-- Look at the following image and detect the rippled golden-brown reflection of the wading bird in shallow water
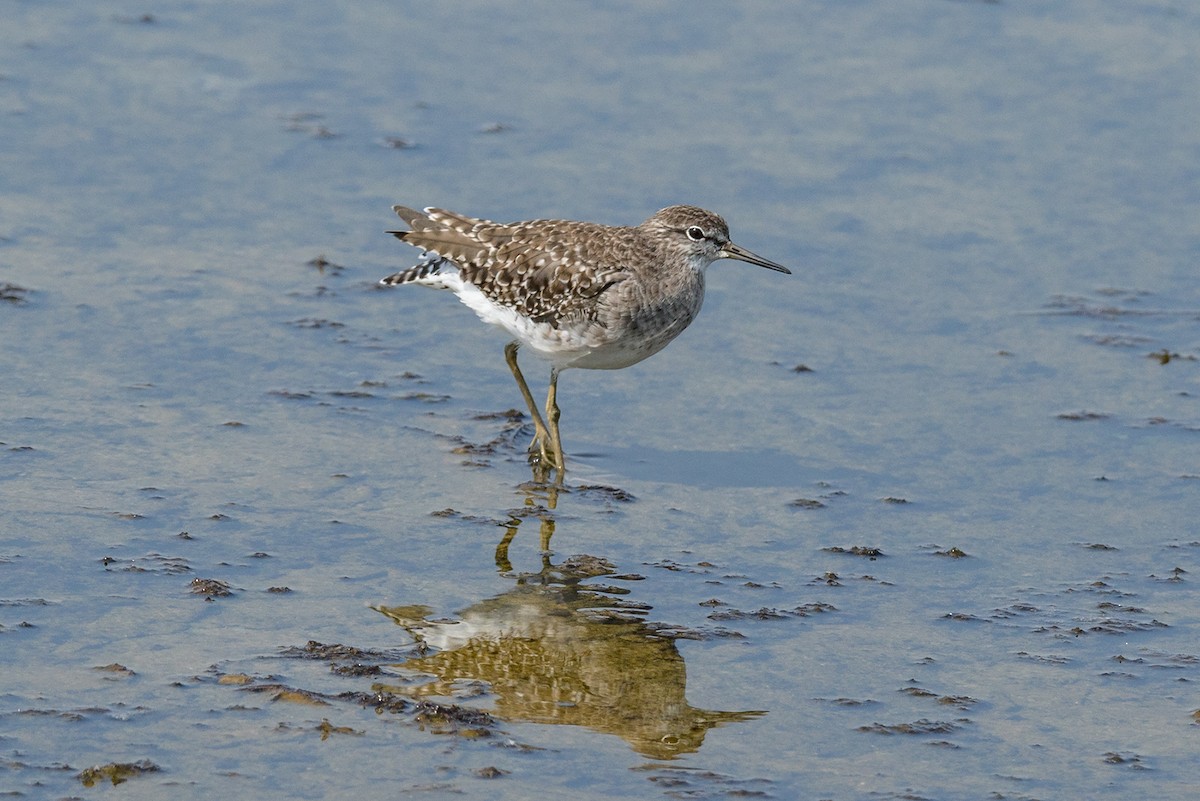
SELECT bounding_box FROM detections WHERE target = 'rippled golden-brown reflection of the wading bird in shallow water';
[377,470,762,759]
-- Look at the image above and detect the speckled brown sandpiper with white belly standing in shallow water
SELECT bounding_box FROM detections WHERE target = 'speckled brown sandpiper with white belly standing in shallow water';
[379,205,792,474]
